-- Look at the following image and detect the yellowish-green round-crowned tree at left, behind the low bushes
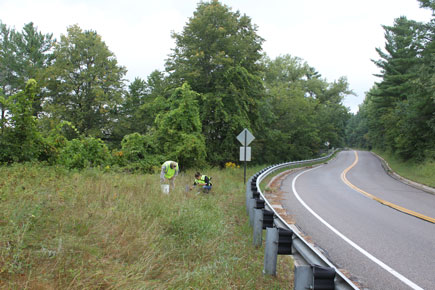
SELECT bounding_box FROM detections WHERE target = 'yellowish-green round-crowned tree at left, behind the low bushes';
[47,25,126,137]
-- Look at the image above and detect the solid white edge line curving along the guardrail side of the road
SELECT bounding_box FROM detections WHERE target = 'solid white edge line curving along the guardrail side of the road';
[292,165,424,290]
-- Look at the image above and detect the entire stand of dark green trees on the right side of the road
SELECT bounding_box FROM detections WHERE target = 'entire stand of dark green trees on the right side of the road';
[346,0,435,161]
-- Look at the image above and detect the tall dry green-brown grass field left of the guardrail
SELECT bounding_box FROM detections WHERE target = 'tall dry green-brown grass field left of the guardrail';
[0,164,293,289]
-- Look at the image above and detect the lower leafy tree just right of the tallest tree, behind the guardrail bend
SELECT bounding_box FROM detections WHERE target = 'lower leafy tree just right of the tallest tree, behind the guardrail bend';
[258,55,352,162]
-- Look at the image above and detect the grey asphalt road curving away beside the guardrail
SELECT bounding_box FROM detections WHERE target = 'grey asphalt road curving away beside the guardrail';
[281,151,435,290]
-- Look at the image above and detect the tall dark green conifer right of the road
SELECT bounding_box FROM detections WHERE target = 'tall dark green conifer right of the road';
[369,17,434,159]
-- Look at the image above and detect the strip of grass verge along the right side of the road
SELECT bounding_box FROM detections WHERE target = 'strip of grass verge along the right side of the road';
[373,150,435,187]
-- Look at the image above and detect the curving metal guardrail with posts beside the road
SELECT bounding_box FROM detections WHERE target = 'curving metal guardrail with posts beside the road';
[246,150,359,290]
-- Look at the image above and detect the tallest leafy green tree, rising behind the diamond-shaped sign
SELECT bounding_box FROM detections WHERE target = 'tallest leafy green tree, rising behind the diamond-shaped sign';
[166,1,264,165]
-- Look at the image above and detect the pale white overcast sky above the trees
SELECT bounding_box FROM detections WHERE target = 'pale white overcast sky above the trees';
[0,0,431,112]
